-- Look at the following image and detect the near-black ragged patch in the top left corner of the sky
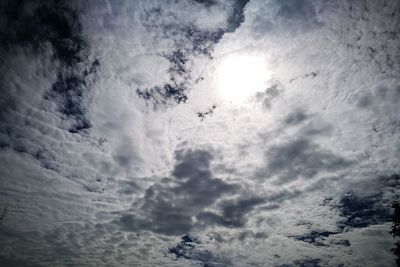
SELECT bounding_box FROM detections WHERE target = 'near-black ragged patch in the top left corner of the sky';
[0,0,100,133]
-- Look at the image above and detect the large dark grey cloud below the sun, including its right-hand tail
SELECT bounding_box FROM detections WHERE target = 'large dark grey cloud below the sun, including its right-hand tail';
[120,150,288,235]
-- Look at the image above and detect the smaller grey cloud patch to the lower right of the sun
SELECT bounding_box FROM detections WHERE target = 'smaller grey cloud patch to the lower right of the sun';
[256,111,346,184]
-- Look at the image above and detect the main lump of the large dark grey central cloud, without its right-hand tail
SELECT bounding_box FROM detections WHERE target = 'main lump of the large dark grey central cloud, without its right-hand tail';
[119,150,238,235]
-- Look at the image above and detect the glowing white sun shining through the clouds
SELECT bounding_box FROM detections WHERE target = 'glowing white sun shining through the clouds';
[215,54,269,104]
